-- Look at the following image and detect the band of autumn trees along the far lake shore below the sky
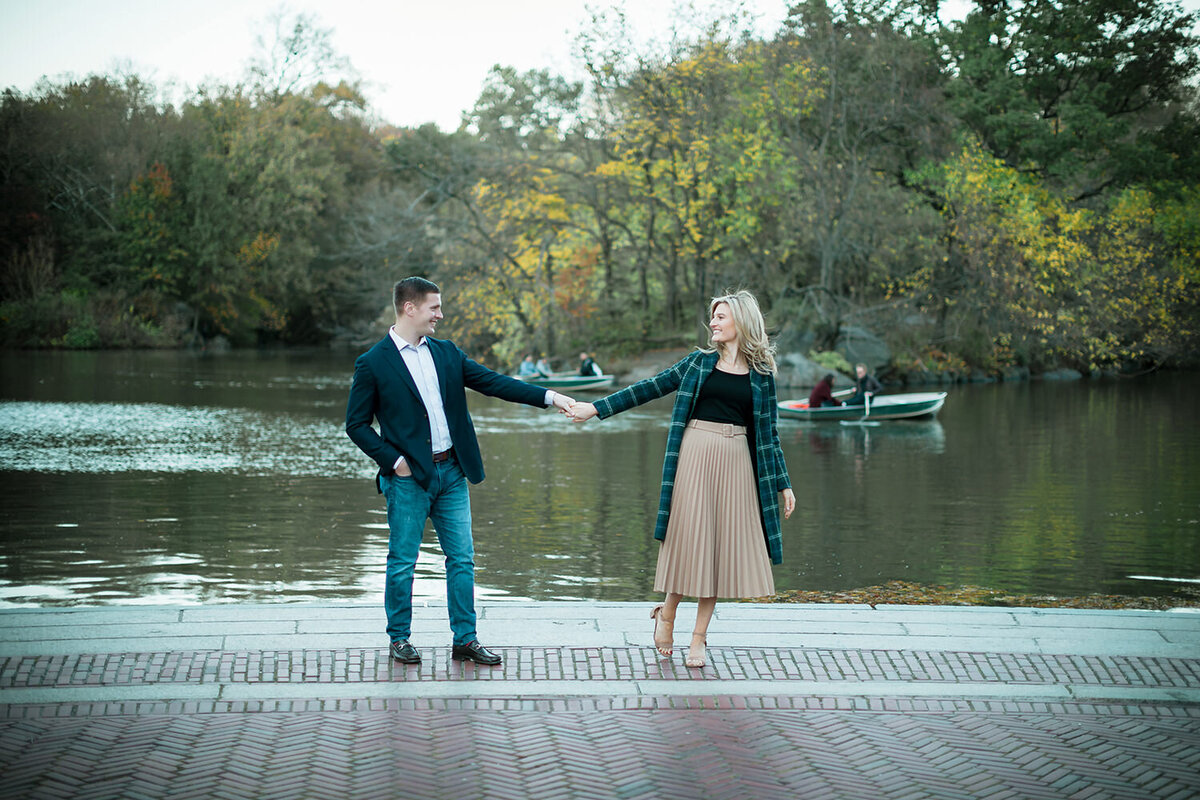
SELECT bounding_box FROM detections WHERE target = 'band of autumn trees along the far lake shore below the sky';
[0,0,1200,374]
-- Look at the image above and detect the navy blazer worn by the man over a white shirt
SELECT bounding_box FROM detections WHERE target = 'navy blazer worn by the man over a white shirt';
[346,336,546,492]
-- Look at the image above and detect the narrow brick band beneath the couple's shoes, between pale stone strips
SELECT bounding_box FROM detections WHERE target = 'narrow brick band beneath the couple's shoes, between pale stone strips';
[0,646,1200,688]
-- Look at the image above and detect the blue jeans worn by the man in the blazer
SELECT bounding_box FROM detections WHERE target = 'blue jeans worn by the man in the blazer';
[383,458,475,644]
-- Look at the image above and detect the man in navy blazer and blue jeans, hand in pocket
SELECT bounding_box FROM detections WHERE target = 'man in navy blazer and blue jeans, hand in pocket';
[346,277,575,666]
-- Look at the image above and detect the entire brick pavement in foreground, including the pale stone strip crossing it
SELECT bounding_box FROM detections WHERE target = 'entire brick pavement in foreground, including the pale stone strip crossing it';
[0,612,1200,800]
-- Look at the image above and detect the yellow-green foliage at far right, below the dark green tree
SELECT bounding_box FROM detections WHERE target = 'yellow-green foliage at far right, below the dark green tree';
[941,133,1200,366]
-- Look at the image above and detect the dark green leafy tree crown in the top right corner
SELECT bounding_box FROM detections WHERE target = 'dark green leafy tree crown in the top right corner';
[943,0,1200,200]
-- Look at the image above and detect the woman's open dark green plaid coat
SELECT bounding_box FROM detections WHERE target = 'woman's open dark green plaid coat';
[593,350,792,564]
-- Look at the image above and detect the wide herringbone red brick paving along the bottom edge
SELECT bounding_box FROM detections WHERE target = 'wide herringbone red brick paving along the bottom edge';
[0,709,1200,800]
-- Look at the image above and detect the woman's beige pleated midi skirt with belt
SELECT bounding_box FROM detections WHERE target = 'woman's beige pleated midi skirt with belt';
[654,420,775,597]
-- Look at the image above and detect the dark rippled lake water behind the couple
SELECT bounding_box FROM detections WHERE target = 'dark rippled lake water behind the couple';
[0,350,1200,607]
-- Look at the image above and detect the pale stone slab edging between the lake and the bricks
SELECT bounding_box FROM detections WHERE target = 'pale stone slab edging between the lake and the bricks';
[0,601,1200,657]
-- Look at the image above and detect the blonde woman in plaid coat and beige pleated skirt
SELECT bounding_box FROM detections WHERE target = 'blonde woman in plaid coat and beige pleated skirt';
[569,291,796,667]
